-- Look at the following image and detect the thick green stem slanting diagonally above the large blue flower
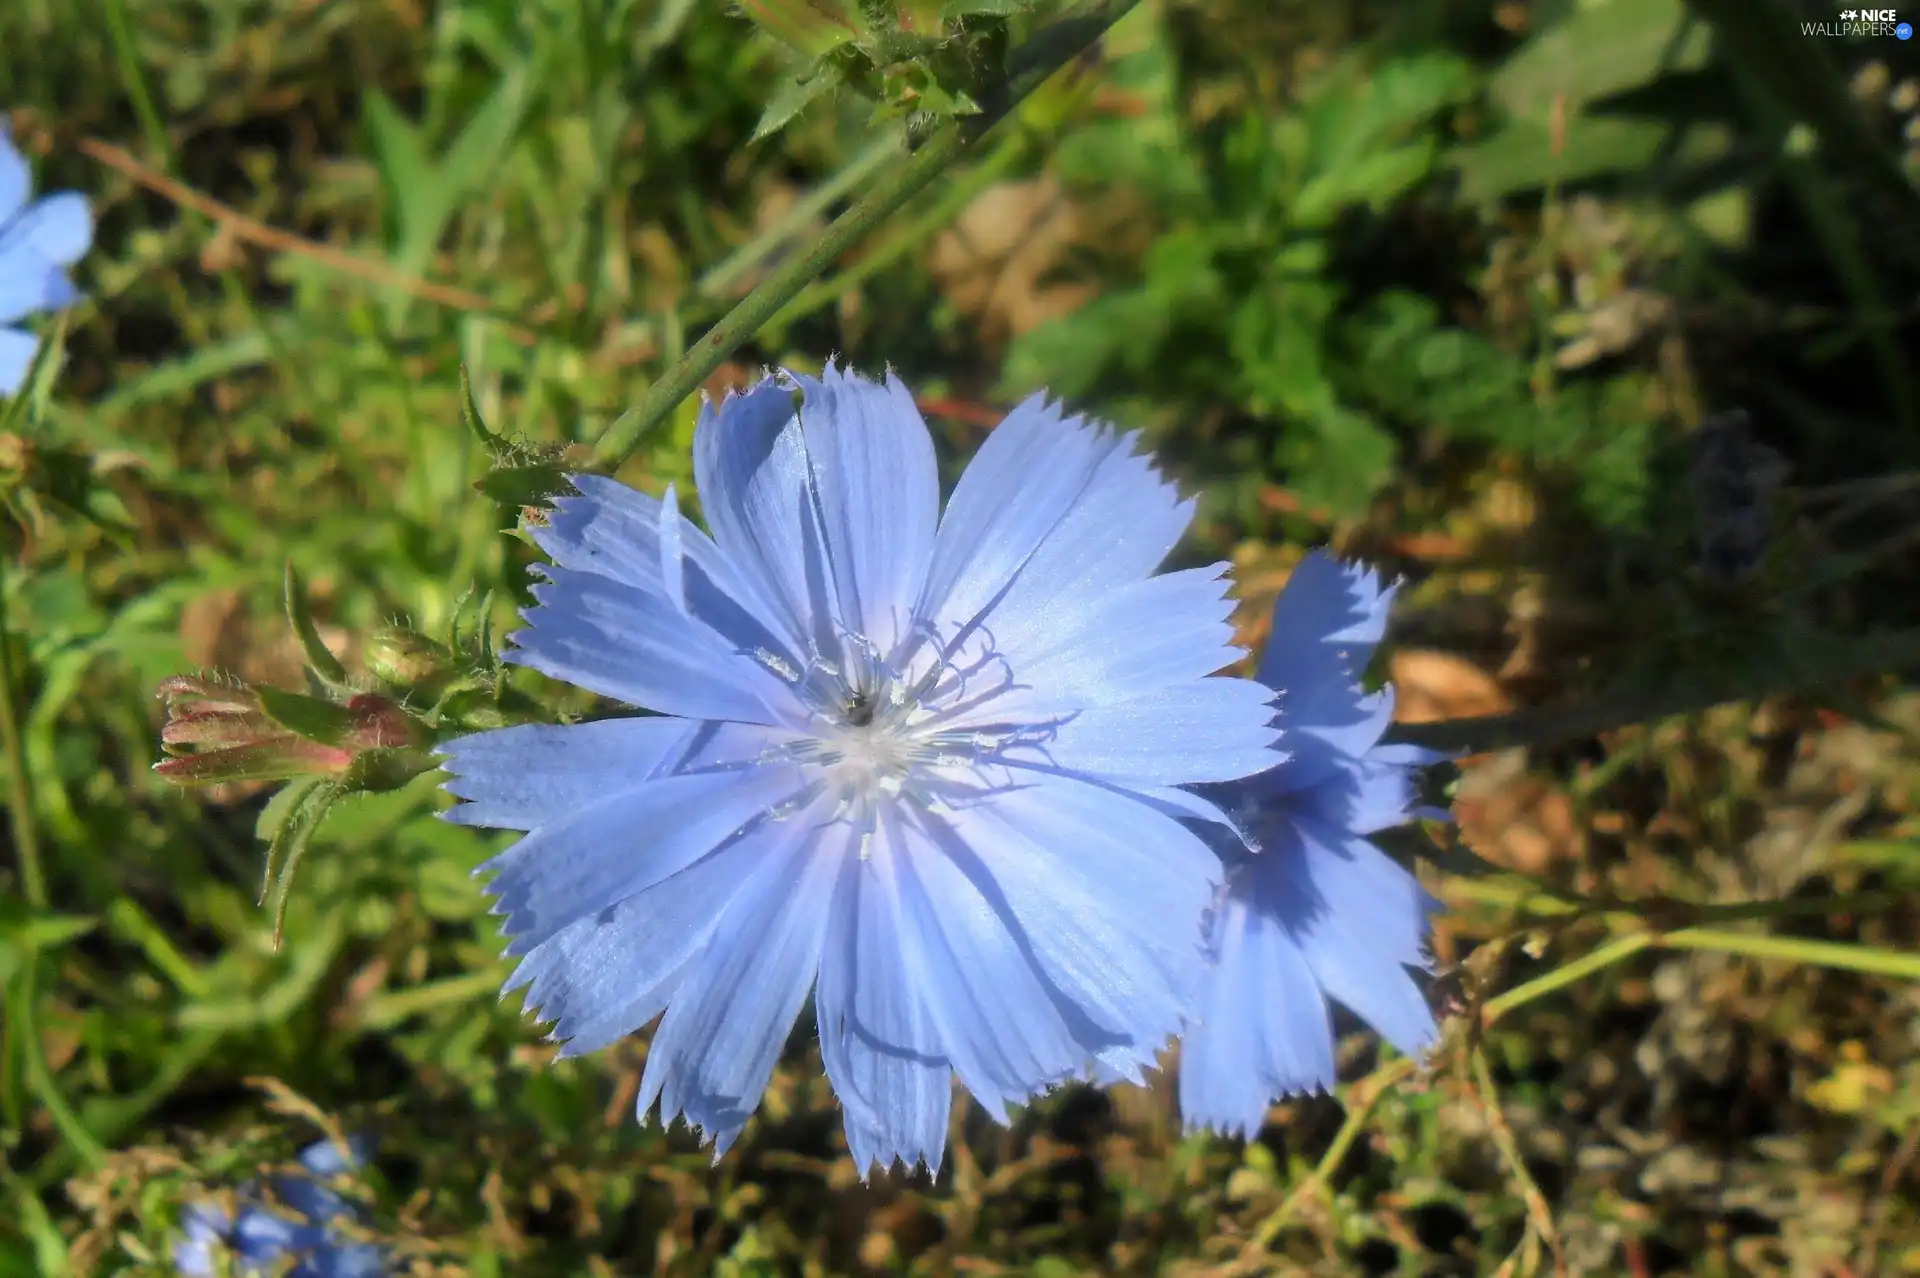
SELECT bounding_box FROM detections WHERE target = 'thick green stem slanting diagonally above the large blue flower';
[591,0,1139,470]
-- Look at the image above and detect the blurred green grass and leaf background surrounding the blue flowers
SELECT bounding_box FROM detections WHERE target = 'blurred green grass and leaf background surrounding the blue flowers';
[0,0,1920,1278]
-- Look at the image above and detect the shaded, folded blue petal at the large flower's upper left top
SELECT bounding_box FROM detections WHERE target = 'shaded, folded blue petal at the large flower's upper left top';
[693,380,839,652]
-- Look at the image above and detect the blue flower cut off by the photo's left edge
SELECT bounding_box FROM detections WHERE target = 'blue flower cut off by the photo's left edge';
[0,122,94,395]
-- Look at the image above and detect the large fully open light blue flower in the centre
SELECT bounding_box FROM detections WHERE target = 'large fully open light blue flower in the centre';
[444,368,1275,1174]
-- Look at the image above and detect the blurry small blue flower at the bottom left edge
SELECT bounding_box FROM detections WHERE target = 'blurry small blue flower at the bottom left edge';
[173,1140,388,1278]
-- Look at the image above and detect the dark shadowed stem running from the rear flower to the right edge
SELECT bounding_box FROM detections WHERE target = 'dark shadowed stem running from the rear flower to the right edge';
[1386,629,1920,754]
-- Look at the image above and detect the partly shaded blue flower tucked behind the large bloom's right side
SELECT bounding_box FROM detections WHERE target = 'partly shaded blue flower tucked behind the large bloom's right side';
[1179,553,1446,1136]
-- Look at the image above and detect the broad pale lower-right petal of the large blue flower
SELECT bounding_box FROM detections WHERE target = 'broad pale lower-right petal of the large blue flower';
[937,779,1219,1075]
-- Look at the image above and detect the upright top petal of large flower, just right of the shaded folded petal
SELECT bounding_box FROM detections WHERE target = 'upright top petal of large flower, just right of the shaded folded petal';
[795,367,941,654]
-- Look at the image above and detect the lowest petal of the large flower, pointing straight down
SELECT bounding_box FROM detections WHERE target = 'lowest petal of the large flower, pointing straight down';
[814,821,952,1178]
